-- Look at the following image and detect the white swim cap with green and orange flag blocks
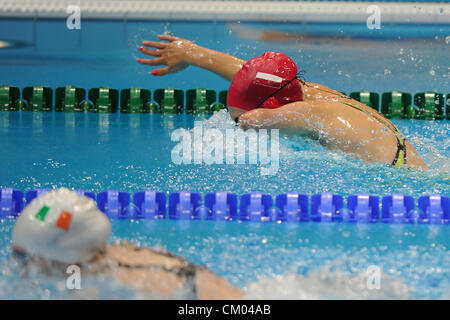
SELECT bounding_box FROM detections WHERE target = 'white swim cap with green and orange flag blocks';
[12,188,111,263]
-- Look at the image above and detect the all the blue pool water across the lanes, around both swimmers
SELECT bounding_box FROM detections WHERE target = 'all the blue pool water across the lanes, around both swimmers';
[0,19,450,299]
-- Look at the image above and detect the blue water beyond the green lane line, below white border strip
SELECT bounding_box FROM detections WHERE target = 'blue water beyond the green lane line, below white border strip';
[0,19,450,93]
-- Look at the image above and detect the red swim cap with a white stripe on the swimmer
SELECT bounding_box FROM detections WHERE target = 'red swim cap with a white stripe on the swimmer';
[227,52,303,110]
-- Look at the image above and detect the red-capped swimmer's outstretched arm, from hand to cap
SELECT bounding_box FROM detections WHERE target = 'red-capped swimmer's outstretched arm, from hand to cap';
[138,35,246,81]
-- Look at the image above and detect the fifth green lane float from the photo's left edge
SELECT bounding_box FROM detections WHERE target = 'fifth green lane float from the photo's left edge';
[120,88,155,113]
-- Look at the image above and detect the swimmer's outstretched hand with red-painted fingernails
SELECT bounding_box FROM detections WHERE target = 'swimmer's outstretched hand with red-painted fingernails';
[138,35,192,76]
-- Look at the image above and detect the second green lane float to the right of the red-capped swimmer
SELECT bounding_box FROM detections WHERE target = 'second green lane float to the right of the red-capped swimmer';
[381,91,415,118]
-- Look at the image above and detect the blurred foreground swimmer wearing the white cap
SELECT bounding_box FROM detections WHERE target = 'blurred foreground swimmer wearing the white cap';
[12,188,242,300]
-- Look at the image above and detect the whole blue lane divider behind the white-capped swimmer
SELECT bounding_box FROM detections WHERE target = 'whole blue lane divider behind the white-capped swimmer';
[0,188,450,224]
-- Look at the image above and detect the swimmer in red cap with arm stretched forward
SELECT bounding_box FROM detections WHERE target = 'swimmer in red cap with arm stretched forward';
[138,35,428,169]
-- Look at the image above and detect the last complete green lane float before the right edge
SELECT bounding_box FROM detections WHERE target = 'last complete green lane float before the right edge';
[414,91,448,120]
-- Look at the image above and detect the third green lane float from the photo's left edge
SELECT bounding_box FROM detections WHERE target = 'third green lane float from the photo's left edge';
[55,86,86,112]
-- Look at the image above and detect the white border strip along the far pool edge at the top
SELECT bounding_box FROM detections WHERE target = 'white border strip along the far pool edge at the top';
[0,0,450,24]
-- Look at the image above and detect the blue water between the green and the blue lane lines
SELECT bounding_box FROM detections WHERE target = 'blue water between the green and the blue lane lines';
[0,112,450,197]
